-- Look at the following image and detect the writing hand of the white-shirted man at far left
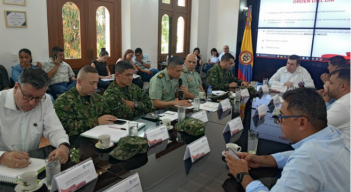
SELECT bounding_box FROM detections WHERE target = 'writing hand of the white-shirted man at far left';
[0,152,30,168]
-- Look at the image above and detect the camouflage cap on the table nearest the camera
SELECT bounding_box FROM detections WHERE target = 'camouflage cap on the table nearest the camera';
[110,136,148,160]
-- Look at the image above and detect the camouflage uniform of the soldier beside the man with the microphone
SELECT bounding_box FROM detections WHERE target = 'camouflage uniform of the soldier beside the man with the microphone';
[103,81,152,120]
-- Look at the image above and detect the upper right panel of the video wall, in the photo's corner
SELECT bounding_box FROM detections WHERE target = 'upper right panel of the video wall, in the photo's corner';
[316,0,351,28]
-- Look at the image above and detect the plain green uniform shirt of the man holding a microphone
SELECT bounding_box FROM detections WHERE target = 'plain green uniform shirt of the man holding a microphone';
[149,68,178,101]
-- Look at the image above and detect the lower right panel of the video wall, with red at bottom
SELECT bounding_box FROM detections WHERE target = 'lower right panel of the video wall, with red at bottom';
[312,29,351,61]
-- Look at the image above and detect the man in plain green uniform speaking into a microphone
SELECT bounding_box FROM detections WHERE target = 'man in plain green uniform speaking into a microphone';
[149,56,191,108]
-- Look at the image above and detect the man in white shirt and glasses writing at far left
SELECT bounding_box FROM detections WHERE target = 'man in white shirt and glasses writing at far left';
[0,68,69,168]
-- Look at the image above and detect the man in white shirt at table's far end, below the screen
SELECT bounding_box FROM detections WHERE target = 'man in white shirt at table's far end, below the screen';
[269,55,314,88]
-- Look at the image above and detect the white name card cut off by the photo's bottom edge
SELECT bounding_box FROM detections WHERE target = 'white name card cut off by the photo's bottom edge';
[104,173,143,192]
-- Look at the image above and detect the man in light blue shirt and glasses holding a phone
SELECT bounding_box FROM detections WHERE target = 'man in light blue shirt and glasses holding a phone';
[226,88,351,192]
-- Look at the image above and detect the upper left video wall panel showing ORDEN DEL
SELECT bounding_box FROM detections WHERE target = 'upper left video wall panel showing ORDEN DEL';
[258,0,318,28]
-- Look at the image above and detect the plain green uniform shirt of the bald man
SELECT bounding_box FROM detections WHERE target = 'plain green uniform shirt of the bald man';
[180,65,202,96]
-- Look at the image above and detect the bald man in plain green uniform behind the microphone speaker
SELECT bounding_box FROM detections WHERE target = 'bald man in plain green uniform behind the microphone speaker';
[180,54,205,99]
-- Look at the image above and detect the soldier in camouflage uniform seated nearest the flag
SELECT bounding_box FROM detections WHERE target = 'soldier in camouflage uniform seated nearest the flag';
[206,53,248,91]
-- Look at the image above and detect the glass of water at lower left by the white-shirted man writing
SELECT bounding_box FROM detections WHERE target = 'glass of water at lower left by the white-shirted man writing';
[45,156,61,190]
